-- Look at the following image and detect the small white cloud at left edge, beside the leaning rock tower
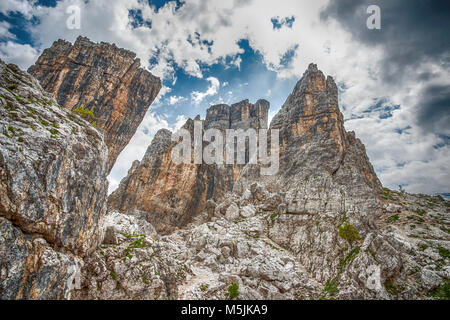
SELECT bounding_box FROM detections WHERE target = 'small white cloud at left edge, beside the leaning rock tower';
[0,41,38,70]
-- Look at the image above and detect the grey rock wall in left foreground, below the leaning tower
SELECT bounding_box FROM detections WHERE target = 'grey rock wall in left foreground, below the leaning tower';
[0,61,108,299]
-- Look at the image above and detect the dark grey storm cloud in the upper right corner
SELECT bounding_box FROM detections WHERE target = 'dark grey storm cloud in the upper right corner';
[321,0,450,133]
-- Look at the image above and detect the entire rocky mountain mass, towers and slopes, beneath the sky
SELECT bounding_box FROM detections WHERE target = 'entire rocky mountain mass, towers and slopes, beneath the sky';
[0,38,450,299]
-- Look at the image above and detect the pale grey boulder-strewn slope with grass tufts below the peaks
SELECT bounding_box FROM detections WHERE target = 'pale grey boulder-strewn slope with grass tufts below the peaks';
[73,190,450,299]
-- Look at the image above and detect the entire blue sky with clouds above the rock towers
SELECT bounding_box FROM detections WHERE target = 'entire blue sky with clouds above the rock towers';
[0,0,450,193]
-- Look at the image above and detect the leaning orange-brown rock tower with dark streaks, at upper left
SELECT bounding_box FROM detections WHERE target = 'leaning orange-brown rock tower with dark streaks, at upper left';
[28,37,161,171]
